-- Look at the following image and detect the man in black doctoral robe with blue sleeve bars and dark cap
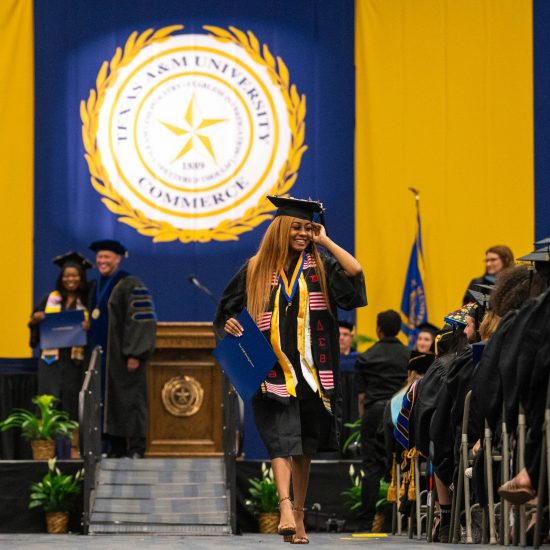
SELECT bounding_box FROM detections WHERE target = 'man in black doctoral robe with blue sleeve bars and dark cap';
[89,240,156,458]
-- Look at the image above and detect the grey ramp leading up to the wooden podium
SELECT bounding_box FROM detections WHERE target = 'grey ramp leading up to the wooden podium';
[89,458,231,535]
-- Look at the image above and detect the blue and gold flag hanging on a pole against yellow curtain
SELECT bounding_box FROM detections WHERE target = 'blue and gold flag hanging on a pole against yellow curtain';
[401,189,428,348]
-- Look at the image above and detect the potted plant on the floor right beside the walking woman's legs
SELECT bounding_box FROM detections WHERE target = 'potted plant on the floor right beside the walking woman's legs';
[245,462,279,533]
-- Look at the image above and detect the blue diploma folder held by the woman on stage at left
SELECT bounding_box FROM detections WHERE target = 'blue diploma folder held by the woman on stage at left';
[40,309,86,349]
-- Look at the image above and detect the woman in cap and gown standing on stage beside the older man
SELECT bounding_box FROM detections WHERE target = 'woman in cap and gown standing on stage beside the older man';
[29,252,92,458]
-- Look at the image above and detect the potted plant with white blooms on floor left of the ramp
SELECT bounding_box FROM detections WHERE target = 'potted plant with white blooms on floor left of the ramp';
[29,458,84,533]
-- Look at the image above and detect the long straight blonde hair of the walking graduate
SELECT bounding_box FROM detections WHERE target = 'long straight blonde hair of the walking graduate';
[246,216,330,320]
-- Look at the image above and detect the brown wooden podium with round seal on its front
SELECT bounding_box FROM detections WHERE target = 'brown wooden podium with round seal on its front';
[145,323,223,457]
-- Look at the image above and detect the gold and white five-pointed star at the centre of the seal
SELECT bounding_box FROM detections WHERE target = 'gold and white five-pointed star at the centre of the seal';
[160,93,227,164]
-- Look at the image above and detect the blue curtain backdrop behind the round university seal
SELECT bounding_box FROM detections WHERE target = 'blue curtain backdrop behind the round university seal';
[34,0,355,458]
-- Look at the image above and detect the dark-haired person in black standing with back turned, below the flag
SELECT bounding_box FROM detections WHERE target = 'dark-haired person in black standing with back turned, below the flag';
[355,310,410,531]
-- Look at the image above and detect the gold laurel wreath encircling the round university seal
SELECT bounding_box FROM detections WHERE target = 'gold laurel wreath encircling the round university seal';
[80,25,307,243]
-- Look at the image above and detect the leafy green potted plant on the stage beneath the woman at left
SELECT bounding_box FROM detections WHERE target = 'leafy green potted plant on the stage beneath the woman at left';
[0,395,78,460]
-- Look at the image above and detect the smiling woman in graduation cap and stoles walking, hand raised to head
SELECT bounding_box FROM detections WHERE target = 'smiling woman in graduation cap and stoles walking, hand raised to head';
[214,196,367,544]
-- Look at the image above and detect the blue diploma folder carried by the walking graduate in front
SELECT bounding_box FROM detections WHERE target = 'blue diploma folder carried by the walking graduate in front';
[212,309,277,400]
